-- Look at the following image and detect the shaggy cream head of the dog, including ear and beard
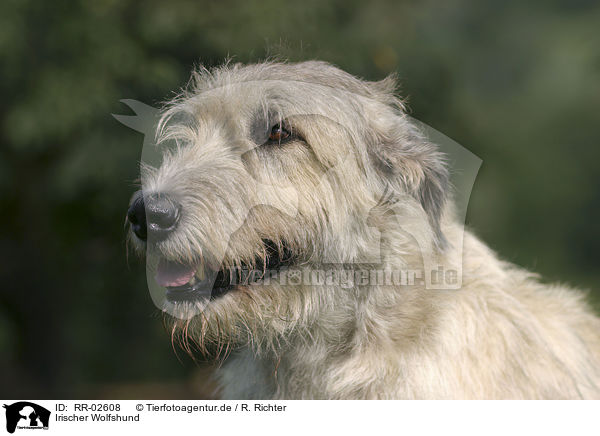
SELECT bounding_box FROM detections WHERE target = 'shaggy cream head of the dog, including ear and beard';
[128,62,447,354]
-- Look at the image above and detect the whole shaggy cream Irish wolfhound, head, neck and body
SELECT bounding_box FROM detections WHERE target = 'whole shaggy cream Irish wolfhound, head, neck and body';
[128,62,600,399]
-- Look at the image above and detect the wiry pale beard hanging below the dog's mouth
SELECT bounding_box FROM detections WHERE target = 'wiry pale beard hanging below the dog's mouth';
[165,272,352,361]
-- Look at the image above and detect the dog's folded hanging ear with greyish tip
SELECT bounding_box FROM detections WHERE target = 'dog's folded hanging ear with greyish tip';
[370,114,449,248]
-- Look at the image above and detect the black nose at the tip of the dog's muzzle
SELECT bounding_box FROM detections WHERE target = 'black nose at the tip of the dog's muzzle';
[127,193,180,241]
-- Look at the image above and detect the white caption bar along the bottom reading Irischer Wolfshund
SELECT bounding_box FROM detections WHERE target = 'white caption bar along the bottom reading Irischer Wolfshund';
[0,400,600,436]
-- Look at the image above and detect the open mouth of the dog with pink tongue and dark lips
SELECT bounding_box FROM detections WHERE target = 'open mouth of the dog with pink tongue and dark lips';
[155,240,295,303]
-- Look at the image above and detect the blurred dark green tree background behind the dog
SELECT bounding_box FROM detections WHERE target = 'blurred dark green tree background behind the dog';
[0,0,600,398]
